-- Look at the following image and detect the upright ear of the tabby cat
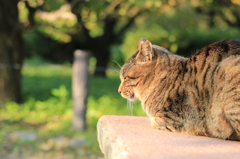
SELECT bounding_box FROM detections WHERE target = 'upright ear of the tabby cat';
[137,38,154,62]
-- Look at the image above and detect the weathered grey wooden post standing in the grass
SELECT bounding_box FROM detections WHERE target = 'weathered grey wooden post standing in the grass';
[72,50,89,131]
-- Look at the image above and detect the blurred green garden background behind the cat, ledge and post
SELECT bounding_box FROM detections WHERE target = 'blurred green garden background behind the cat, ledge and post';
[0,0,240,159]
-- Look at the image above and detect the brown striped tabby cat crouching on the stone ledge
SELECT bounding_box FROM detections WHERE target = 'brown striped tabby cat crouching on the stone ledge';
[118,38,240,140]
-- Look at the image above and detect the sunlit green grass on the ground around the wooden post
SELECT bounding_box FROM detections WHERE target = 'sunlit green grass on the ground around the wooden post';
[0,60,144,158]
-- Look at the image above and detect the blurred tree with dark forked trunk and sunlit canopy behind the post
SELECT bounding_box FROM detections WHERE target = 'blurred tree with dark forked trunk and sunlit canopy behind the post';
[18,0,159,76]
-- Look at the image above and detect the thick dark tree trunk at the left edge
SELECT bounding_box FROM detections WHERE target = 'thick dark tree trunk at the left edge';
[0,0,23,103]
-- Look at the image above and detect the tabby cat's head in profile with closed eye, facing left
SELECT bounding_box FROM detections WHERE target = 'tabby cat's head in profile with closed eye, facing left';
[118,38,158,100]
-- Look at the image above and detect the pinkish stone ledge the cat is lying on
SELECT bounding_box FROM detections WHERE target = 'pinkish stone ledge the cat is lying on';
[97,115,240,159]
